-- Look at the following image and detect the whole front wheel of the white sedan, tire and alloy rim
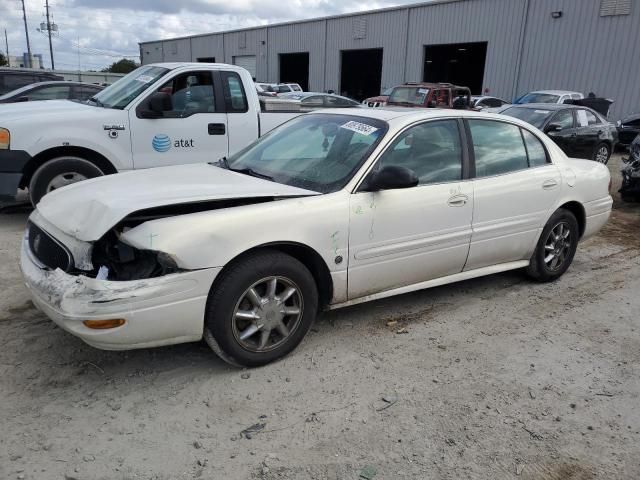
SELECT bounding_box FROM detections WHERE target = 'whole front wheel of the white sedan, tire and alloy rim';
[205,250,318,367]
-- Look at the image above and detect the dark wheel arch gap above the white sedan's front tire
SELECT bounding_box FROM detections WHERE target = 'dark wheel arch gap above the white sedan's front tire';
[212,241,333,310]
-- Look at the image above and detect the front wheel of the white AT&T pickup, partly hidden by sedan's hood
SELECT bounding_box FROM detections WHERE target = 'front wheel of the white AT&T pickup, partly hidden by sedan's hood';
[29,157,103,207]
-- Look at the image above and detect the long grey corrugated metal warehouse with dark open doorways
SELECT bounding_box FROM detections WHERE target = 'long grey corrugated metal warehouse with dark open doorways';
[140,0,640,120]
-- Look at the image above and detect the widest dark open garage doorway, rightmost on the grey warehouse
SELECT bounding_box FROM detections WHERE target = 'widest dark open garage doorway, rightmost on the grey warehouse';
[423,42,487,95]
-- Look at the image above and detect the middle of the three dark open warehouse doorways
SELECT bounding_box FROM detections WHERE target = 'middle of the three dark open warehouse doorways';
[340,48,382,101]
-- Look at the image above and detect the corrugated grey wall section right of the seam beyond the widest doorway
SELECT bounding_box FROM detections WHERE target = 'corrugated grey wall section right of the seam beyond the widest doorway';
[517,0,640,119]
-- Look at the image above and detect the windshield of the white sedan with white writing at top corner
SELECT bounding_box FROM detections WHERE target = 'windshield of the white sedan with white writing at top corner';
[227,113,388,193]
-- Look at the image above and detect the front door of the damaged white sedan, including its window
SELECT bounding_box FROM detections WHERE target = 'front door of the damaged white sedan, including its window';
[348,119,473,299]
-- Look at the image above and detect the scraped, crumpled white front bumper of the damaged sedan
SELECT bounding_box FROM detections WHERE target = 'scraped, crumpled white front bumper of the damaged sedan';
[20,235,221,350]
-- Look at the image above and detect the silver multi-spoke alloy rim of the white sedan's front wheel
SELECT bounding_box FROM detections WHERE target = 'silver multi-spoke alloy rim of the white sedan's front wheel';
[232,276,304,352]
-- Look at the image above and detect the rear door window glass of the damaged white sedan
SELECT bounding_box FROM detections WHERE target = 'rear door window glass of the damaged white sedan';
[469,120,529,177]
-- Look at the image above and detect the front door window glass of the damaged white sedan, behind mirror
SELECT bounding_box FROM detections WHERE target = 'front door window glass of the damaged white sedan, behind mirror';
[378,120,462,185]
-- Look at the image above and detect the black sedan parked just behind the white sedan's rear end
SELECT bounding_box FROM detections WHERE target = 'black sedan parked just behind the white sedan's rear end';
[501,103,618,164]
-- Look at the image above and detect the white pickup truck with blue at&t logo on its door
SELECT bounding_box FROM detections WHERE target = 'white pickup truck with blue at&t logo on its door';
[0,63,300,205]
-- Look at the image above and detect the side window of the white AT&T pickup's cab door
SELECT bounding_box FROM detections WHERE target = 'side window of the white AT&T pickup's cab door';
[157,71,215,118]
